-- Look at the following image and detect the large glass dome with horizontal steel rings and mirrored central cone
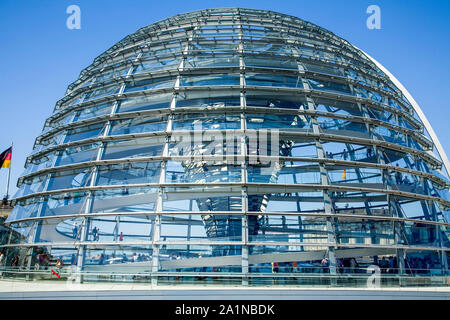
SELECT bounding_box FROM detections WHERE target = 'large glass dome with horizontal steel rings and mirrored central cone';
[3,8,450,283]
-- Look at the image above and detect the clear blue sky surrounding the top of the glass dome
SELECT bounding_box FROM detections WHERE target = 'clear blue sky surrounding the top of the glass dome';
[0,0,450,196]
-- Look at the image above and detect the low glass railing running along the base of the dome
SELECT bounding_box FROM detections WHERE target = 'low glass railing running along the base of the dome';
[0,266,450,289]
